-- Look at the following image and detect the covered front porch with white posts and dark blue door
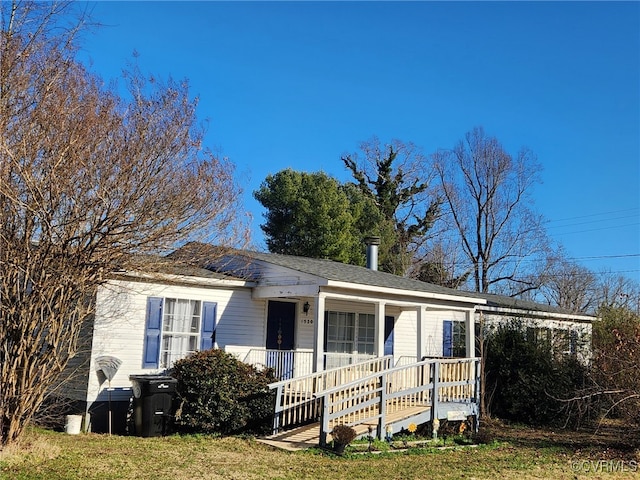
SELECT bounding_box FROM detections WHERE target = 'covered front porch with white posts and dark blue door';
[224,286,475,380]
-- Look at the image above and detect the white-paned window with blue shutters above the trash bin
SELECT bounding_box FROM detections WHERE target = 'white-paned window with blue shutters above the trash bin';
[143,297,216,368]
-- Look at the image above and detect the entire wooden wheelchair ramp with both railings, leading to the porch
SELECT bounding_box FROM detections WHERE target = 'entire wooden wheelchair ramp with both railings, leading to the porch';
[260,357,479,450]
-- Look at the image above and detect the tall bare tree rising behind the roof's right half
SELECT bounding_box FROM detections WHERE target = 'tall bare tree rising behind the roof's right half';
[433,128,547,295]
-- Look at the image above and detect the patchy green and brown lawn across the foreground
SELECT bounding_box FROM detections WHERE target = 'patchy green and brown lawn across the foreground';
[0,427,640,480]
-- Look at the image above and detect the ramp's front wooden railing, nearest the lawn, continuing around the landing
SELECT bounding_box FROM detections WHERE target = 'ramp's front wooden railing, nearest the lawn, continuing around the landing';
[315,358,479,445]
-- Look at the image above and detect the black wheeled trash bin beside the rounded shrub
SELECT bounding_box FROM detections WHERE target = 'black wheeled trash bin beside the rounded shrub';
[129,375,178,437]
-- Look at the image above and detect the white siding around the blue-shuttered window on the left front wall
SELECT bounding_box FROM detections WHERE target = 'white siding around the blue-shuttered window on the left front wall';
[87,281,265,403]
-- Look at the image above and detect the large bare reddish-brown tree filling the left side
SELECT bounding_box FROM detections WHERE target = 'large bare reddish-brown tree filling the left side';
[0,2,246,446]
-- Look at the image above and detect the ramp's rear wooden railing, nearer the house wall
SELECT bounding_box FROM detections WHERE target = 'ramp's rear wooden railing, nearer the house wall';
[269,356,393,433]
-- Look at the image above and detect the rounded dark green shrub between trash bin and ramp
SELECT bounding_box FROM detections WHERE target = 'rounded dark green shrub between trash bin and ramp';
[171,349,276,435]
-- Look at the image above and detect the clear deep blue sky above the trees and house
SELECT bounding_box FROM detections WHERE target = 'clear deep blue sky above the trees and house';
[77,1,640,281]
